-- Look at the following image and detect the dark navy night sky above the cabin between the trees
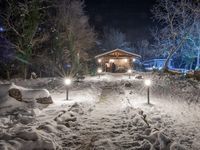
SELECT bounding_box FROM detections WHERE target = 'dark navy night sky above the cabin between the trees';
[85,0,155,42]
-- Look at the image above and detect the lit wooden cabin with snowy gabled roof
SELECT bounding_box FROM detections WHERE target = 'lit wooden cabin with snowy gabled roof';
[95,49,141,73]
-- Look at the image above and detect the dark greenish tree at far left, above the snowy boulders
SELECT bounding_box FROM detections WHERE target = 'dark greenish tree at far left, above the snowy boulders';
[1,0,40,79]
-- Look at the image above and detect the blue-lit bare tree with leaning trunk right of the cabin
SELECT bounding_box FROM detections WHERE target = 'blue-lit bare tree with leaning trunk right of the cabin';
[152,0,196,70]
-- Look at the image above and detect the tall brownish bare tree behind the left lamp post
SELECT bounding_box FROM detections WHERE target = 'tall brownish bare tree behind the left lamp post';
[50,0,96,75]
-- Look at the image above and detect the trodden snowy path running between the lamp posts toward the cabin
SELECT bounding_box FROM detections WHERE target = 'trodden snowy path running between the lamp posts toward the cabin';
[64,87,148,150]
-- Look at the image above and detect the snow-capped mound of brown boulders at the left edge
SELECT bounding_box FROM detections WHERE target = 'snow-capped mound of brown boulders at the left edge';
[0,84,53,114]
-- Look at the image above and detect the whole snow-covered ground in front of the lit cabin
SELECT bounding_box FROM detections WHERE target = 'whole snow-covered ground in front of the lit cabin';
[0,73,200,150]
